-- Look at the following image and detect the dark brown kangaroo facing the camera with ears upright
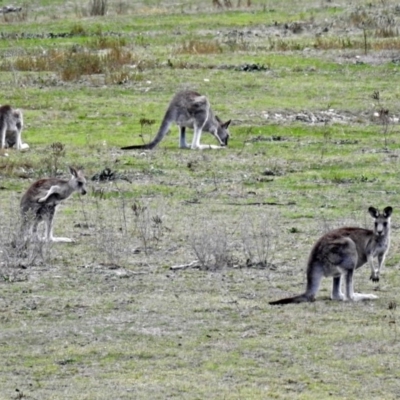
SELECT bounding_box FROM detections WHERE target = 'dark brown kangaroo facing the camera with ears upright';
[269,207,393,305]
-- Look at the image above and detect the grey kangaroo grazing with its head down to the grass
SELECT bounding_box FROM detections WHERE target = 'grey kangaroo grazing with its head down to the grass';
[122,91,231,150]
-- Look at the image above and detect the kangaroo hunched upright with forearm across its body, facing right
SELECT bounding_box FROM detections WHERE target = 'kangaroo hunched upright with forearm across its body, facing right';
[20,167,86,243]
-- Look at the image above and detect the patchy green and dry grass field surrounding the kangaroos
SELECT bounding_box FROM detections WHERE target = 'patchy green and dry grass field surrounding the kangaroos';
[0,0,400,400]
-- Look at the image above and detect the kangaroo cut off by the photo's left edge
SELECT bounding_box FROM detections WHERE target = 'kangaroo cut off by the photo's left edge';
[0,105,29,150]
